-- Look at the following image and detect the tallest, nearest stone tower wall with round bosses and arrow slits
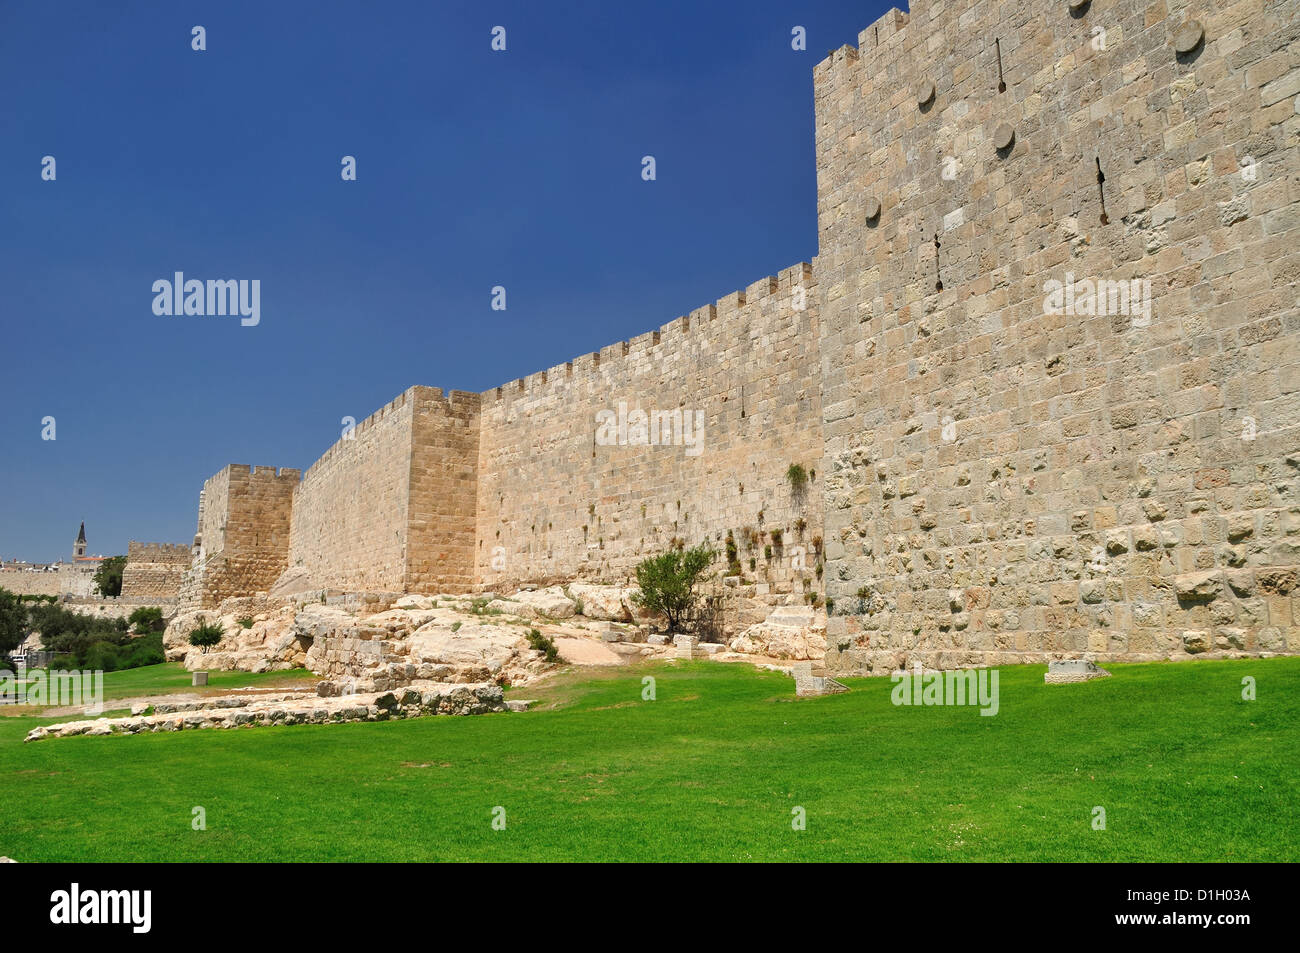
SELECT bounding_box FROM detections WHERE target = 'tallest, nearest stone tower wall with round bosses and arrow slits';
[814,0,1300,673]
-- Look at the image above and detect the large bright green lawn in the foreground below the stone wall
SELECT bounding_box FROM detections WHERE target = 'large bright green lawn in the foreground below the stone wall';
[0,658,1300,861]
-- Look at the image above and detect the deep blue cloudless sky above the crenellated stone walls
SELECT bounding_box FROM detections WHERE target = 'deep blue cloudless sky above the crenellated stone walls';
[0,0,888,560]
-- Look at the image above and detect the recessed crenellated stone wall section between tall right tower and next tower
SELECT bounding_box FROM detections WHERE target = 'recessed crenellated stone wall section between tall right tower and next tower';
[476,264,822,590]
